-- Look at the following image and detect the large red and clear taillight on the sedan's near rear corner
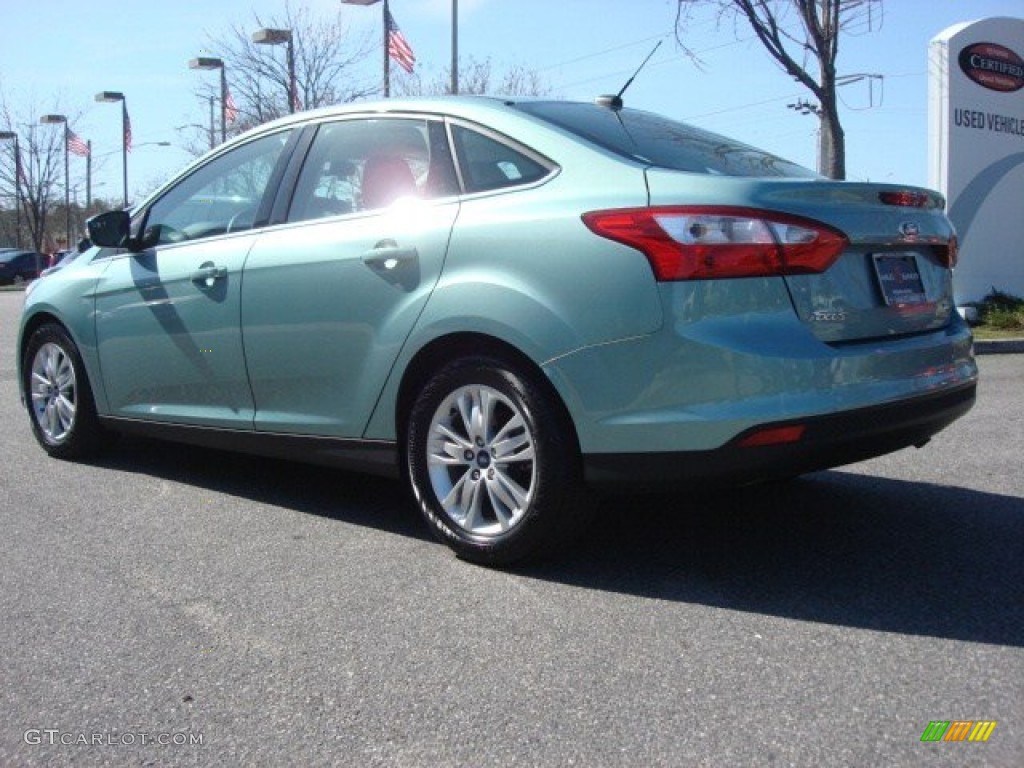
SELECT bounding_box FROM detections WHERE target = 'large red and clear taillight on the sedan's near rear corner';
[583,206,849,281]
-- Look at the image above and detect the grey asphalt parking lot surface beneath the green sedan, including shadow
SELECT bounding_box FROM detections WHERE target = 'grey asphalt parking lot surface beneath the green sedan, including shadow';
[0,293,1024,768]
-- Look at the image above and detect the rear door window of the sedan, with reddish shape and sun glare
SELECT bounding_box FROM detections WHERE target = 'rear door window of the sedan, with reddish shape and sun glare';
[288,118,458,221]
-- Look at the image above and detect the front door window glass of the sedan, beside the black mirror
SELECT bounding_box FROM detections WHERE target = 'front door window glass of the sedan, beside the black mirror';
[143,131,290,245]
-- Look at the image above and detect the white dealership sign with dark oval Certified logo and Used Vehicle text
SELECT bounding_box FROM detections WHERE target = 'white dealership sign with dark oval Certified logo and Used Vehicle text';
[928,18,1024,304]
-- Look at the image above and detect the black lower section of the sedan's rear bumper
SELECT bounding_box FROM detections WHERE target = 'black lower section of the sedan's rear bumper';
[584,381,977,492]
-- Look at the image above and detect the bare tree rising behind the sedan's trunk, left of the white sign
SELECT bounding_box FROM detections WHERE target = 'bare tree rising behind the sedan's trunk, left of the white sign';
[676,0,882,179]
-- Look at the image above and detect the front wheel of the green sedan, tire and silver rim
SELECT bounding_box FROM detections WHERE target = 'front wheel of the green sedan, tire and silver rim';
[22,323,110,459]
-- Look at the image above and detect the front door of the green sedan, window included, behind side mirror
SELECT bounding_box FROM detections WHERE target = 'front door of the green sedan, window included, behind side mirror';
[95,126,290,429]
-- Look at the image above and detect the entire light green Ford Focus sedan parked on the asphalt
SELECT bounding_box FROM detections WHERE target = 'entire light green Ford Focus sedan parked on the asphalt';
[18,97,977,564]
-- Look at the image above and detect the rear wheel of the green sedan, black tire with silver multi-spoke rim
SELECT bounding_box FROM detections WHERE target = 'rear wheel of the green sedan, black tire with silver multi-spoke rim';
[404,356,590,565]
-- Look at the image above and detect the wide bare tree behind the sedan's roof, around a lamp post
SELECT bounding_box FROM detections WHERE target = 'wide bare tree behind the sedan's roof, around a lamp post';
[183,3,378,152]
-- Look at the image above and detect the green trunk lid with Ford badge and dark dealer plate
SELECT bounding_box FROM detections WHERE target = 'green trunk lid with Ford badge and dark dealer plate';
[647,174,954,342]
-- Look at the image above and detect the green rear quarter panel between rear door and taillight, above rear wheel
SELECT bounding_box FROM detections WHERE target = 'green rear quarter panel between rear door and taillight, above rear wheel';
[366,147,663,439]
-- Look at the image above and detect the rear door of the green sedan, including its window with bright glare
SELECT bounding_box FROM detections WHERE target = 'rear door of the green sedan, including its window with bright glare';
[242,116,459,437]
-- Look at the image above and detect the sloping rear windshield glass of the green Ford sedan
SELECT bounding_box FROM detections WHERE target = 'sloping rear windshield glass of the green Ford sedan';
[515,101,817,178]
